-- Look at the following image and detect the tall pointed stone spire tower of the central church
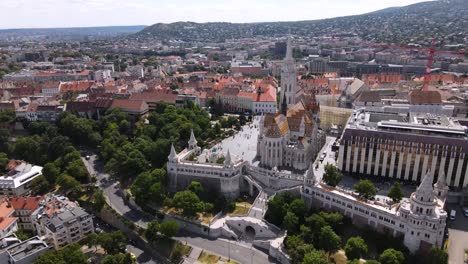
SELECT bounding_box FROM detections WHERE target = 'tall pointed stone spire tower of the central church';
[280,36,297,112]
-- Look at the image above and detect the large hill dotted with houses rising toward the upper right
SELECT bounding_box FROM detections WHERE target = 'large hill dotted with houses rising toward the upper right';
[131,0,468,44]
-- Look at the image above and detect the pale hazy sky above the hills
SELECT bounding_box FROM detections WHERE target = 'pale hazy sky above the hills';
[0,0,432,29]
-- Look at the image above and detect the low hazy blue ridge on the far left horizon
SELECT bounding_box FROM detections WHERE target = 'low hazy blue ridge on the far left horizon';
[0,26,146,39]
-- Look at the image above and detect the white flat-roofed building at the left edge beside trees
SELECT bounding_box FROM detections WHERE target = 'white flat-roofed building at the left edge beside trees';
[0,160,42,196]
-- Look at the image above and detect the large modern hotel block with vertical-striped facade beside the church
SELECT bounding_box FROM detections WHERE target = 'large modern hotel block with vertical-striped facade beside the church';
[337,110,468,188]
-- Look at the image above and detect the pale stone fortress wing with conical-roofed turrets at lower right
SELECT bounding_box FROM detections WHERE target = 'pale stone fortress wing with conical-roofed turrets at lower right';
[302,165,448,253]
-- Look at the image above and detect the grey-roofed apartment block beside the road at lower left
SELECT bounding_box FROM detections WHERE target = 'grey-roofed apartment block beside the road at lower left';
[32,194,94,249]
